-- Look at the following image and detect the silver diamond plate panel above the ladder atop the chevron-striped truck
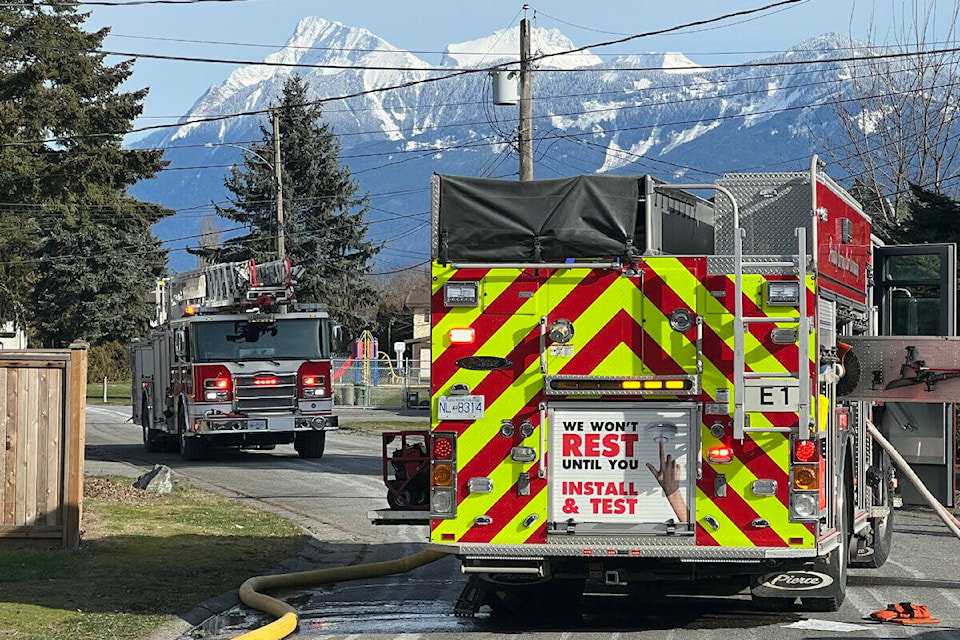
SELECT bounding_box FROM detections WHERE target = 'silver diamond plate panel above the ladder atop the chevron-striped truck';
[714,173,813,255]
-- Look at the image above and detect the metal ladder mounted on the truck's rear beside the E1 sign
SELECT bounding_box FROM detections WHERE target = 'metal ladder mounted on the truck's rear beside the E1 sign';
[733,225,811,440]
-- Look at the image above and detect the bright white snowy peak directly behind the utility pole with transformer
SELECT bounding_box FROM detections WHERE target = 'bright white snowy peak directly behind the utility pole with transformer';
[441,27,602,69]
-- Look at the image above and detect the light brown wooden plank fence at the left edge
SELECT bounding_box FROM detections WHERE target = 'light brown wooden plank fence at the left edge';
[0,344,87,549]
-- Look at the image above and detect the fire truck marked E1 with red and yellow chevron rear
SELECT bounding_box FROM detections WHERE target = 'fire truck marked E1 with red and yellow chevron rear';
[370,158,960,614]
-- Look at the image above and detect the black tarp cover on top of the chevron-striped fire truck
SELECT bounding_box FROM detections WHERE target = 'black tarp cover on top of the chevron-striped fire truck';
[434,175,645,262]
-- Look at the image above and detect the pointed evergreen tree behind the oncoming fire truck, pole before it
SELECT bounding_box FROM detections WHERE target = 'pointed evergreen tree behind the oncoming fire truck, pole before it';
[209,75,380,337]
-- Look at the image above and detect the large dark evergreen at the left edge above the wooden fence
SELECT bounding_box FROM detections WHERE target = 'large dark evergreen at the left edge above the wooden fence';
[0,1,170,347]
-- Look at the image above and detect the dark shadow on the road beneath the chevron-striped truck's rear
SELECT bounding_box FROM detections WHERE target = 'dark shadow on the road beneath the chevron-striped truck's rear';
[480,596,802,633]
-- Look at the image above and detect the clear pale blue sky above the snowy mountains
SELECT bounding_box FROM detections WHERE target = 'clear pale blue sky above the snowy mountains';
[86,0,955,132]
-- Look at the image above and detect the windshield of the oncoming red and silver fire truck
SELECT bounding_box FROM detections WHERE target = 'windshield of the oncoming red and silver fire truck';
[194,318,330,362]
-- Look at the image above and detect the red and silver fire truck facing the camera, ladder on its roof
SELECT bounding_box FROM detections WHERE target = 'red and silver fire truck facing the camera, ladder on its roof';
[131,260,337,460]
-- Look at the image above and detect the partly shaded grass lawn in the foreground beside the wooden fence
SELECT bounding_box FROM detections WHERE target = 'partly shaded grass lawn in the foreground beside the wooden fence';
[0,477,309,640]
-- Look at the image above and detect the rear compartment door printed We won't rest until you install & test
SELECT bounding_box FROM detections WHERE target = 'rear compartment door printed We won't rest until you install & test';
[548,403,698,535]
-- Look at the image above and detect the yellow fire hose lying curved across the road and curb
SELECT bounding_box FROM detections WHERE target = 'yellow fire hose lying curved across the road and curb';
[234,551,449,640]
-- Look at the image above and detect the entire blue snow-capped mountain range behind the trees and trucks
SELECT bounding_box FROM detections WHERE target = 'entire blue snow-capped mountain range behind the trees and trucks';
[134,18,867,270]
